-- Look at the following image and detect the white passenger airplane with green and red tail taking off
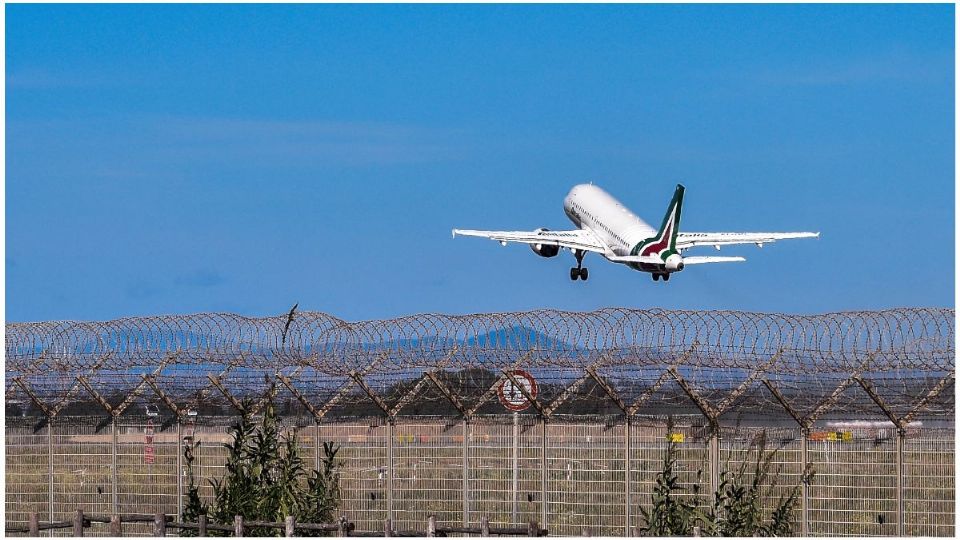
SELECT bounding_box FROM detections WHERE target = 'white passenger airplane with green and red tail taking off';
[453,183,820,281]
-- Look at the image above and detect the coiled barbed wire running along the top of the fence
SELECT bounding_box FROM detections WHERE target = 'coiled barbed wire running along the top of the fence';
[6,308,955,422]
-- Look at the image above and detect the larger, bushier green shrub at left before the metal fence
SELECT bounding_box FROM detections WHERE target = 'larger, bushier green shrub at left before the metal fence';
[183,400,340,536]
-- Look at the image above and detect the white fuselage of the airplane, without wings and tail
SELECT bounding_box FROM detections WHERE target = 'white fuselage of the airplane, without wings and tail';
[563,184,657,255]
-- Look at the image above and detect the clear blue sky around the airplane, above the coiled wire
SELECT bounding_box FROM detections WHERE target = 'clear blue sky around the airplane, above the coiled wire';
[6,5,954,321]
